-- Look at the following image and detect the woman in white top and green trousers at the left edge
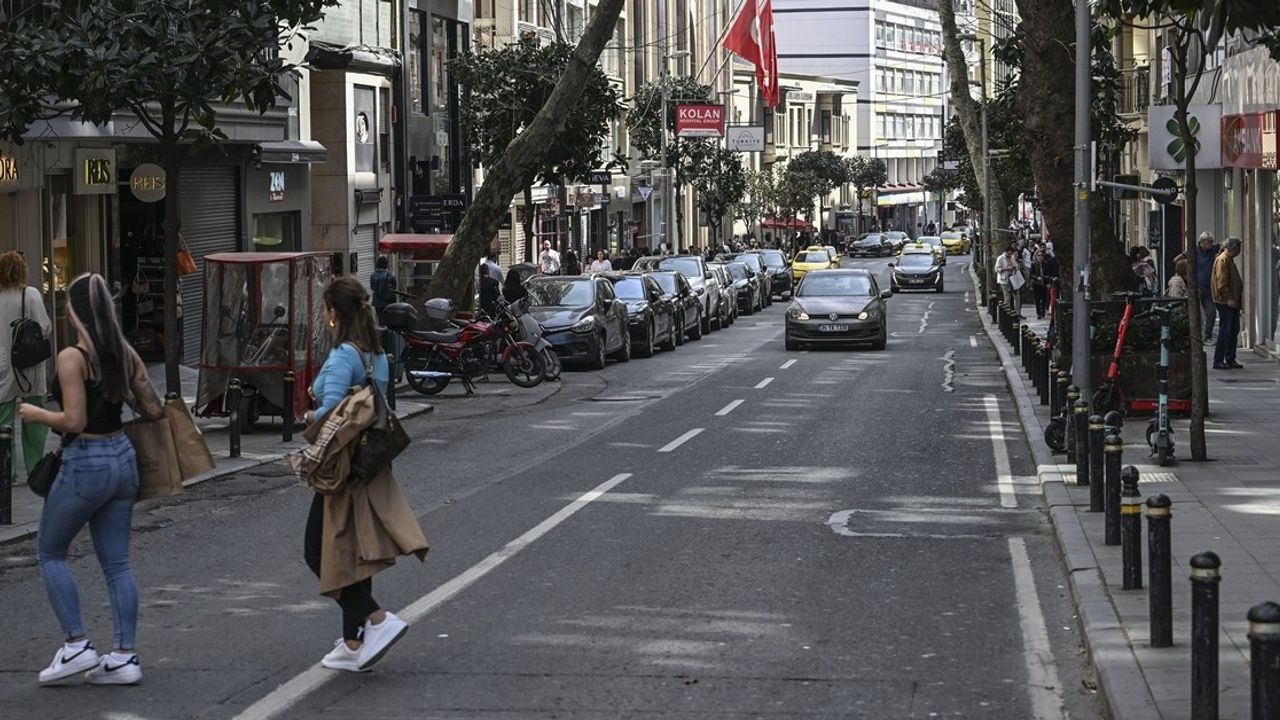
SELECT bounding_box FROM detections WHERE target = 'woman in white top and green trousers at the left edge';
[0,250,52,484]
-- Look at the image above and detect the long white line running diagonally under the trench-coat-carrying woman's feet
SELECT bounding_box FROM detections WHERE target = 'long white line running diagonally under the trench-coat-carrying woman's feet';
[236,473,631,720]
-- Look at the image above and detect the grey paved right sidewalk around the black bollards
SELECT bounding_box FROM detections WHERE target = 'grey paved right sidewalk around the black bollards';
[975,283,1280,720]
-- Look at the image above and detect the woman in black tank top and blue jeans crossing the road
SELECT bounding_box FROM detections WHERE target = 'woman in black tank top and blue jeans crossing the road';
[18,273,164,685]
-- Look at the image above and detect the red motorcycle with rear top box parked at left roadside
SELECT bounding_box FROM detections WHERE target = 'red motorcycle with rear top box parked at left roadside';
[383,299,547,395]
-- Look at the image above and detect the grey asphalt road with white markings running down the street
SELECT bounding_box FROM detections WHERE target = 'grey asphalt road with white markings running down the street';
[0,256,1100,720]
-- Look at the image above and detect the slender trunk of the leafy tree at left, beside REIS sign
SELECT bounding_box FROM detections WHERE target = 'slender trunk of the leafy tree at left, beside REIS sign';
[160,124,183,397]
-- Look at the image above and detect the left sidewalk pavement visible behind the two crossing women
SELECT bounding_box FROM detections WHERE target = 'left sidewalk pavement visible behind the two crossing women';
[0,365,450,544]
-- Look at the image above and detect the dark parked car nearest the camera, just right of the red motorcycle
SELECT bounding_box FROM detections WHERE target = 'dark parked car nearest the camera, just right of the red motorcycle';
[525,275,631,370]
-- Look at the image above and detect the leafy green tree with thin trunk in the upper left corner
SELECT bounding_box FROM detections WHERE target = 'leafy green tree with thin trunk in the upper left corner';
[0,0,337,391]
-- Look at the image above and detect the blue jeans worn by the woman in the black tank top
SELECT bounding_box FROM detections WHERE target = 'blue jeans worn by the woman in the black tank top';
[36,433,138,650]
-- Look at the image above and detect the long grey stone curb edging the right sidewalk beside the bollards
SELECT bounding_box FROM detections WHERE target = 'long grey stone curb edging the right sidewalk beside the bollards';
[970,270,1161,720]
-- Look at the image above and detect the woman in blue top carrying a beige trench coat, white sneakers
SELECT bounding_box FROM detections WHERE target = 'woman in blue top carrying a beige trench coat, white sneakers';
[296,277,426,673]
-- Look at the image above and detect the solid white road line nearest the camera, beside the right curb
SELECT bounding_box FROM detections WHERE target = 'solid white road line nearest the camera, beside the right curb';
[1009,538,1068,720]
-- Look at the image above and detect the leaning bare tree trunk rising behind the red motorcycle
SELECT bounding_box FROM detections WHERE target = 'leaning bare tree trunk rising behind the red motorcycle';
[431,0,625,306]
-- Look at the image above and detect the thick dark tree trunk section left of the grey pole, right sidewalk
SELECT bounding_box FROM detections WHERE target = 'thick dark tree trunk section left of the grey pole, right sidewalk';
[1016,0,1075,285]
